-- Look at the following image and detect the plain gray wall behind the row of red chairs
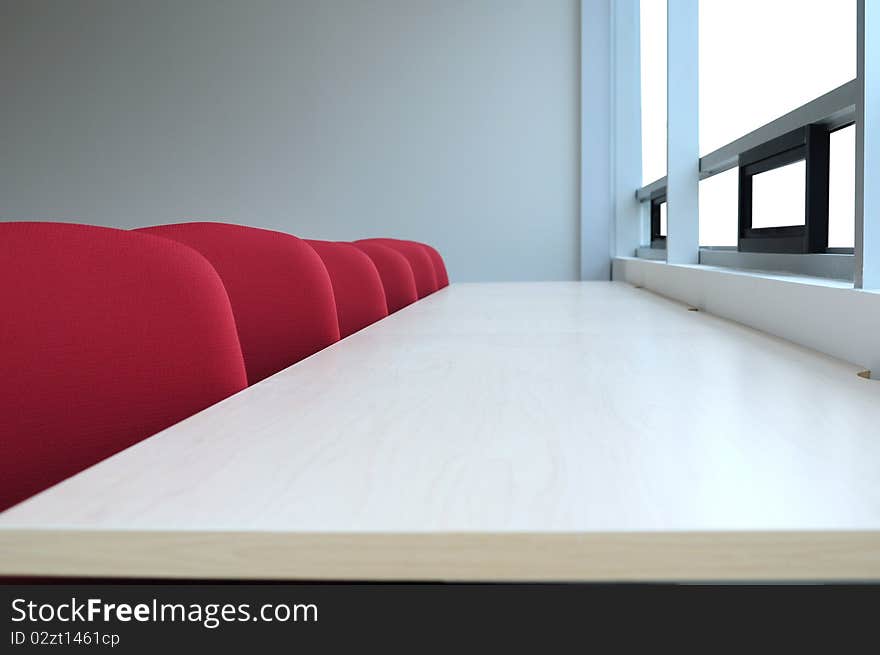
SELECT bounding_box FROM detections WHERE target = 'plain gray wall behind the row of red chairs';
[0,0,579,281]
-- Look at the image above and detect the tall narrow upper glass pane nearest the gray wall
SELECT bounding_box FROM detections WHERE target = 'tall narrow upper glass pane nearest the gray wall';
[639,0,666,184]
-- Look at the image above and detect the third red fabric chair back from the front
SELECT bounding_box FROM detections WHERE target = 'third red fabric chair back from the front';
[306,240,388,337]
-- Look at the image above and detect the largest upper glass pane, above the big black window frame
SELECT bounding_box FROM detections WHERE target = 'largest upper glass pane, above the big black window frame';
[696,0,856,154]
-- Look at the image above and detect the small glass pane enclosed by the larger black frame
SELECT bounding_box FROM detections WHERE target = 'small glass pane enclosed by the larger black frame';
[752,160,807,227]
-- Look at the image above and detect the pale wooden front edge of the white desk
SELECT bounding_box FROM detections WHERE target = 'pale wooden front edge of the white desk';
[0,528,880,582]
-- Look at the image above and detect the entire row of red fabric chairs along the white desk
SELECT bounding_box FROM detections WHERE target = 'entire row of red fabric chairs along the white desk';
[0,222,449,510]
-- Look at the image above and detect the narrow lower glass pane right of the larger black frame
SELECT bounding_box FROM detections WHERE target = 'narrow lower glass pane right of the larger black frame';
[828,125,856,248]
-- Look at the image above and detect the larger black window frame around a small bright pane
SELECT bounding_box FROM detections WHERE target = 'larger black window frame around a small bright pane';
[739,125,830,253]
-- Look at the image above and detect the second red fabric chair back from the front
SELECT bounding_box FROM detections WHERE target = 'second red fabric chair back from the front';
[140,223,339,384]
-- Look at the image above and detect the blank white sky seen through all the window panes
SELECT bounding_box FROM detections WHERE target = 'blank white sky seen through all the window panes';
[641,0,856,247]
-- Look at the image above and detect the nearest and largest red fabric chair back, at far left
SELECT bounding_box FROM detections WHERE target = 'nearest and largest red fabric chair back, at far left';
[0,223,247,509]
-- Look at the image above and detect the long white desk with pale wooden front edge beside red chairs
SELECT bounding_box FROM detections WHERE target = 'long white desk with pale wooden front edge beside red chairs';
[0,282,880,580]
